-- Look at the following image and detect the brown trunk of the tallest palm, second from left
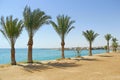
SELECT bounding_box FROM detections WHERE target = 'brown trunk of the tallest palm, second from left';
[28,36,33,63]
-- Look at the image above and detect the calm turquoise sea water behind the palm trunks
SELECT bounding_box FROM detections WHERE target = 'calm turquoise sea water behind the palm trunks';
[0,49,105,64]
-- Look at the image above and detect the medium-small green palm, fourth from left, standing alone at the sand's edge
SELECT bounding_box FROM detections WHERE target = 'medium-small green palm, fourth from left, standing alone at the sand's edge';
[83,30,99,56]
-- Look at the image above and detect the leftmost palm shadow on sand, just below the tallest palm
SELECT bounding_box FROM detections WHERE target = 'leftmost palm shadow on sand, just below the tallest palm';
[17,62,52,73]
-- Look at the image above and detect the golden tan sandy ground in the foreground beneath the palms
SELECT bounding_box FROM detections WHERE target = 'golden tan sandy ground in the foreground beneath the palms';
[0,53,120,80]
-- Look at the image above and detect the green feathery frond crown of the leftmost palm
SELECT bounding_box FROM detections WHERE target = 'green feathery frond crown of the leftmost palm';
[0,16,23,43]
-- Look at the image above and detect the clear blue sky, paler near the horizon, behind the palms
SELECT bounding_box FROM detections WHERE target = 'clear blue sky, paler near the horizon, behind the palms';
[0,0,120,48]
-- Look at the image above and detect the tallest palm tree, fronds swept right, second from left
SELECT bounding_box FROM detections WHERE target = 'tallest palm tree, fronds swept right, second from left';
[23,6,51,63]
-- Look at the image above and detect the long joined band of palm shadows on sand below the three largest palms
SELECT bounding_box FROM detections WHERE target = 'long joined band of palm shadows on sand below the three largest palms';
[17,61,80,73]
